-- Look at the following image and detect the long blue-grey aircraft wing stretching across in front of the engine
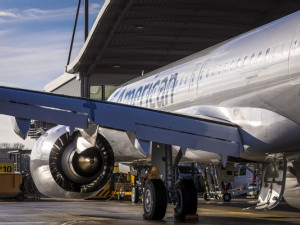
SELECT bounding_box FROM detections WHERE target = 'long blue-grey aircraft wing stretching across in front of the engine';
[0,87,243,163]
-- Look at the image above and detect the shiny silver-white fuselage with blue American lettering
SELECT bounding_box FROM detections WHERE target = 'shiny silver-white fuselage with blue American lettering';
[102,12,300,161]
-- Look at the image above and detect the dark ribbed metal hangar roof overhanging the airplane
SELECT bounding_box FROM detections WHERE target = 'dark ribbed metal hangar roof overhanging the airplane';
[67,0,300,81]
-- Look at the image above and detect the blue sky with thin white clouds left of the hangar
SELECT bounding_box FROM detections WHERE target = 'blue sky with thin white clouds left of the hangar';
[0,0,104,147]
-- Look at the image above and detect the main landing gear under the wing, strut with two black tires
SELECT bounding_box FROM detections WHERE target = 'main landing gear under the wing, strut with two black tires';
[143,143,197,220]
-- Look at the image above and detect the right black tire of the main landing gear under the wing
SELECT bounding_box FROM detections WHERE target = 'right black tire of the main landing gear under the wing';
[174,180,198,220]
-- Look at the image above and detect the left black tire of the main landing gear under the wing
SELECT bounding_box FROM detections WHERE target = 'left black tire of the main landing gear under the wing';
[143,179,167,220]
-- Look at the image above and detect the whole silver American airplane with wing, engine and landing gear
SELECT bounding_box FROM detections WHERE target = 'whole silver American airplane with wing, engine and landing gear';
[0,9,300,220]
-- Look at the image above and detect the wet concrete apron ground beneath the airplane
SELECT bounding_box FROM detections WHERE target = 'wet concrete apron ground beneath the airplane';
[0,198,300,225]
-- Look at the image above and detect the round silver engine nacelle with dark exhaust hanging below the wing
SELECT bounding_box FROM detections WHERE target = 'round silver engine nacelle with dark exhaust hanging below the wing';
[30,126,114,199]
